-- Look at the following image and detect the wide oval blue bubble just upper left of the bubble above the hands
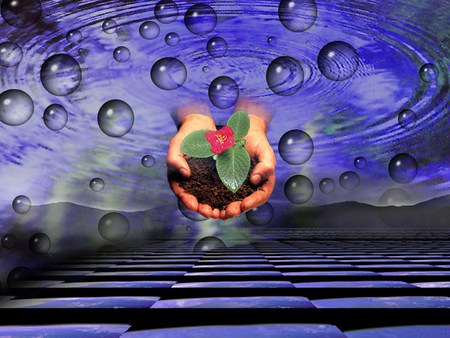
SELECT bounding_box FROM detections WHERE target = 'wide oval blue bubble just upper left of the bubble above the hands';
[150,57,187,90]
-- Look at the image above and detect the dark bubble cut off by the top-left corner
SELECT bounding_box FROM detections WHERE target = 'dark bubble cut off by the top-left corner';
[1,0,42,28]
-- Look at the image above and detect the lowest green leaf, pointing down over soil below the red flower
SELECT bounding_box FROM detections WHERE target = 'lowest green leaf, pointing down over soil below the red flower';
[216,146,250,193]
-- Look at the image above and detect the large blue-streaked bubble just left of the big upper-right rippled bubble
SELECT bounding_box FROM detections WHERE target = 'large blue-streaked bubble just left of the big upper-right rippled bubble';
[266,56,304,96]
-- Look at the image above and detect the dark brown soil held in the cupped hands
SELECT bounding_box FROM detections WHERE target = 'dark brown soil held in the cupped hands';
[177,157,260,210]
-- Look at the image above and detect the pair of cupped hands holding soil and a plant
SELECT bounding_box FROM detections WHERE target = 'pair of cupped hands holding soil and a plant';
[167,101,276,220]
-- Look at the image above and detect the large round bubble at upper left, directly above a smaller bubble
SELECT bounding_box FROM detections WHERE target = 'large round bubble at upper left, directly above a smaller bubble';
[41,54,81,96]
